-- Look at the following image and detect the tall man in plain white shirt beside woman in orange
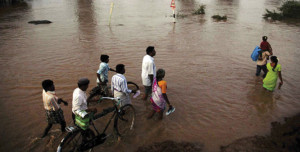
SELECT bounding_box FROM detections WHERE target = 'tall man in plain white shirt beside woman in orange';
[142,46,156,100]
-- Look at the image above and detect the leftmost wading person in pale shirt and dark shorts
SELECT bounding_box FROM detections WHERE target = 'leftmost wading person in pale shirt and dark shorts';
[42,80,68,138]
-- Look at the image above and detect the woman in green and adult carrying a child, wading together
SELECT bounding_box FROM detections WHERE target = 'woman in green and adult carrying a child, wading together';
[256,36,283,91]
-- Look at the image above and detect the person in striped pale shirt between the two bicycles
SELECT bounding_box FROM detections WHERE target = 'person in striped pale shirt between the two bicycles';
[111,64,136,107]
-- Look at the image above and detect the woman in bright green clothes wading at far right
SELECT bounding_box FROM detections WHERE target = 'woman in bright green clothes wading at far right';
[263,56,283,91]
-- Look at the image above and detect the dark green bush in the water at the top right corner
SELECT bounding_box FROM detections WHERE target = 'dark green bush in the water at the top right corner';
[263,0,300,20]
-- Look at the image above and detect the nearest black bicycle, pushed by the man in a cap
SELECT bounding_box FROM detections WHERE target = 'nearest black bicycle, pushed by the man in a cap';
[57,97,135,152]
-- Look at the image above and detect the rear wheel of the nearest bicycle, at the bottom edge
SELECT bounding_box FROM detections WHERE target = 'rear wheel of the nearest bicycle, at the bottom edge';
[57,129,95,152]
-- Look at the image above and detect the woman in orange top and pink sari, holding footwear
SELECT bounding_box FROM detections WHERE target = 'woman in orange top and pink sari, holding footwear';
[148,69,175,120]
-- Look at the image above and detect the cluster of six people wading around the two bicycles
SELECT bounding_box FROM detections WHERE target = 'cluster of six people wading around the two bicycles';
[42,46,175,138]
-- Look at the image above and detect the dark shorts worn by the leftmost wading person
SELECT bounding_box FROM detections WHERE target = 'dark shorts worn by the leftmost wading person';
[46,109,65,124]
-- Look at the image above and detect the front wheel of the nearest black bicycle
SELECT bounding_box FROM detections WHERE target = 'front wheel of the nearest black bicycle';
[114,104,135,136]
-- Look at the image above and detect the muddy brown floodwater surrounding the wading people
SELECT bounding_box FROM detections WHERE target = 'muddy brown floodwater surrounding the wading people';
[0,0,300,152]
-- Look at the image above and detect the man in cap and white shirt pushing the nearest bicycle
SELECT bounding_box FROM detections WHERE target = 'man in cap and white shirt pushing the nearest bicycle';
[72,78,97,123]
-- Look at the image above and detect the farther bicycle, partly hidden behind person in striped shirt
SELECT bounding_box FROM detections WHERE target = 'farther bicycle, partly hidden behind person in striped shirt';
[87,81,139,102]
